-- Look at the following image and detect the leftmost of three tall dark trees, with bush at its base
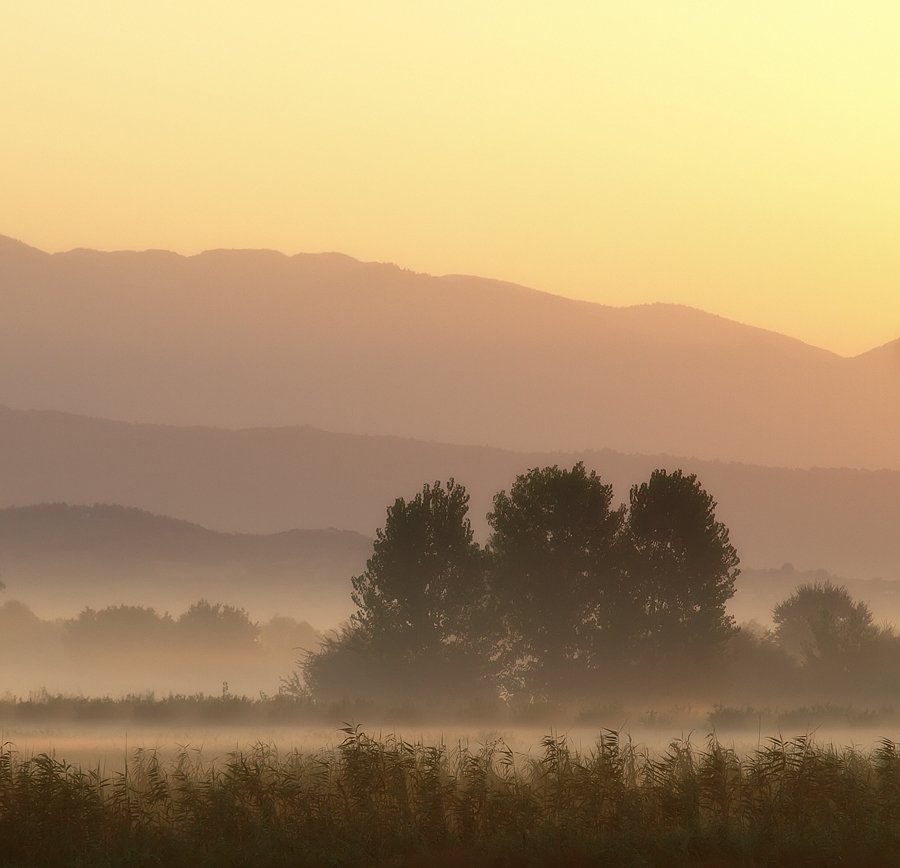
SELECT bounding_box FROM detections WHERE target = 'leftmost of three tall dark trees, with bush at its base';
[304,479,485,695]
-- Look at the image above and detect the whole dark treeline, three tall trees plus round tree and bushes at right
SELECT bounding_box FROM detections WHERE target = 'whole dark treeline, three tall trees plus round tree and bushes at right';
[298,463,900,708]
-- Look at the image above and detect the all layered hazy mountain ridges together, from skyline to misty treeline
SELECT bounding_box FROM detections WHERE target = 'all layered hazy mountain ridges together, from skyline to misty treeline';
[0,237,900,626]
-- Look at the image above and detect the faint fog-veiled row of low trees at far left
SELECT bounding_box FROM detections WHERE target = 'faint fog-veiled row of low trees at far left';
[0,600,321,696]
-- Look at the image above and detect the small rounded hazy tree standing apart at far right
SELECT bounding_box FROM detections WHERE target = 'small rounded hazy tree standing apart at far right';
[772,581,879,672]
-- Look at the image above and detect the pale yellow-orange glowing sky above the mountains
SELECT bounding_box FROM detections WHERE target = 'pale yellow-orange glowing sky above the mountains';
[0,0,900,355]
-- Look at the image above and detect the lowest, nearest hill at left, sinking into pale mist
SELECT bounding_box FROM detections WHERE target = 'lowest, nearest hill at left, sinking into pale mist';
[0,503,372,629]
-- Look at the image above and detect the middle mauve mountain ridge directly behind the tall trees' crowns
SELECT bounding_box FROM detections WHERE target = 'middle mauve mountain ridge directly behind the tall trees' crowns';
[0,409,900,584]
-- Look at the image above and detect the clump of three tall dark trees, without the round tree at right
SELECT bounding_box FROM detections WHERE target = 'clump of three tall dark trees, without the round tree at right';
[302,463,738,700]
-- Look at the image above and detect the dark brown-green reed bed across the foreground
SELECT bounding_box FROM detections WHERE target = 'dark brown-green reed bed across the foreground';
[0,726,900,866]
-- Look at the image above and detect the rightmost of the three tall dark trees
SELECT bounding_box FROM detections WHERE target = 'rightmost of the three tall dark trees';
[628,470,740,662]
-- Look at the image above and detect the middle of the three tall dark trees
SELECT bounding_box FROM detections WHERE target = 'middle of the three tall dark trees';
[488,462,626,696]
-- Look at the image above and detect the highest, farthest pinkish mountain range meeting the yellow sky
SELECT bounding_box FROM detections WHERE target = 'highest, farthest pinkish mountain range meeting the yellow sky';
[0,238,900,468]
